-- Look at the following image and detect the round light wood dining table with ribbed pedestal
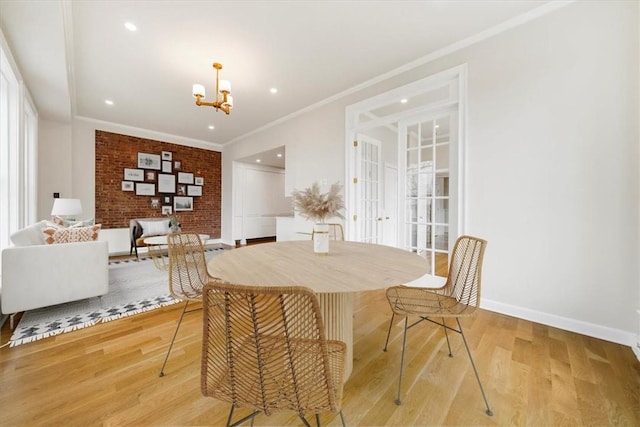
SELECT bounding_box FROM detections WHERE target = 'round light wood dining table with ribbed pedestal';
[208,240,427,379]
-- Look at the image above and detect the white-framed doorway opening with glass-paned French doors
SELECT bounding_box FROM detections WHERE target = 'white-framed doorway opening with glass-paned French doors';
[345,65,466,274]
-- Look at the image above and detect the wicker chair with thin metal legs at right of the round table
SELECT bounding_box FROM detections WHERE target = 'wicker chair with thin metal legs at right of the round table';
[384,236,493,415]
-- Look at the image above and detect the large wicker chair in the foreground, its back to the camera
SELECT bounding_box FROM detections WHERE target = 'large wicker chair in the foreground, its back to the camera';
[201,283,346,426]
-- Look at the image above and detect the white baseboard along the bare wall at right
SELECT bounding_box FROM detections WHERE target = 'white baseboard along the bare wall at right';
[480,299,640,360]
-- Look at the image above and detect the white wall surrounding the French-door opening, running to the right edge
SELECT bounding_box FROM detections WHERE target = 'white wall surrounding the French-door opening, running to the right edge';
[223,2,640,345]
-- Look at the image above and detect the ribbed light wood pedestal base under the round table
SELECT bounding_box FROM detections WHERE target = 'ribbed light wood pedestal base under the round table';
[318,292,353,381]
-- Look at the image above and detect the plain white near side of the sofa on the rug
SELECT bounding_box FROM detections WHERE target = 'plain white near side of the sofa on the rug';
[1,241,109,314]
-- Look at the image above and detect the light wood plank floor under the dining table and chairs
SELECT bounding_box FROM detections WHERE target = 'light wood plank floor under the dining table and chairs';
[0,284,640,426]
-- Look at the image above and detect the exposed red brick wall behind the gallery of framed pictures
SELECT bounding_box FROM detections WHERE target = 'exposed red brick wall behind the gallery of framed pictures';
[95,130,222,239]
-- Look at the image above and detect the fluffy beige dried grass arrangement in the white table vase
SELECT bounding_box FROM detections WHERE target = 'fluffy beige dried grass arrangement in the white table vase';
[291,182,344,223]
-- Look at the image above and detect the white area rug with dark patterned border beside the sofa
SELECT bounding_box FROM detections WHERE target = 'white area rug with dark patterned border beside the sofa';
[9,248,224,347]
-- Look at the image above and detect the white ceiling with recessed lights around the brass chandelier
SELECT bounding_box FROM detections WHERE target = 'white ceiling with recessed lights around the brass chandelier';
[0,0,548,149]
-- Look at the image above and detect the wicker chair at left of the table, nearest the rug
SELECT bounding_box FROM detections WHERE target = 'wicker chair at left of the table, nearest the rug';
[159,232,219,377]
